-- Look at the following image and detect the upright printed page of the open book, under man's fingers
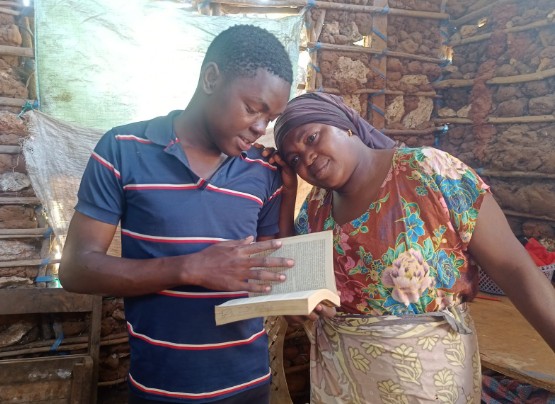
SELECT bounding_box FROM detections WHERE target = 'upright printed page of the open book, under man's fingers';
[250,230,337,296]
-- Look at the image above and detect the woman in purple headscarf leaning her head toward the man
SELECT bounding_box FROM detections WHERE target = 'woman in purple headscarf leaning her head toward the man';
[274,93,555,403]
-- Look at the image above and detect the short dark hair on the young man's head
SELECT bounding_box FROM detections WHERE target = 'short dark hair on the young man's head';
[202,25,293,84]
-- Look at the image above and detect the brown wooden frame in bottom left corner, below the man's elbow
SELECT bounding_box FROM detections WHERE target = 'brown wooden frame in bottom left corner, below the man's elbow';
[0,289,102,404]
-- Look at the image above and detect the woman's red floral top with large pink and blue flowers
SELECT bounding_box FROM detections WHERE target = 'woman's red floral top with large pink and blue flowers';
[295,148,488,316]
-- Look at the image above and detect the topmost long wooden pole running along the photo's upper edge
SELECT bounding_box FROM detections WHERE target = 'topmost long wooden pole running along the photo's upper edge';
[206,0,449,20]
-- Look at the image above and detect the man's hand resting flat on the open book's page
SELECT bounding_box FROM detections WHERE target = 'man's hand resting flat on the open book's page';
[185,236,295,293]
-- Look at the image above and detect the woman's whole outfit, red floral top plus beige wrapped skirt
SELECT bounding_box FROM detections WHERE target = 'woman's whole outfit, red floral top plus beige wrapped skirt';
[295,148,488,404]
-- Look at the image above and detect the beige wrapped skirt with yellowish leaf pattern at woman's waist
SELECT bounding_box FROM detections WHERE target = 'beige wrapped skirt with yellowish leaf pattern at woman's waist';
[307,304,482,404]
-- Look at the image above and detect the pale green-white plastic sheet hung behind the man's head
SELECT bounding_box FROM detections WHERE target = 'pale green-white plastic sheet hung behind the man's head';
[35,0,302,130]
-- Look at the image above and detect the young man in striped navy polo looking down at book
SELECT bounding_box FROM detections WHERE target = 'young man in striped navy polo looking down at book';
[60,25,293,404]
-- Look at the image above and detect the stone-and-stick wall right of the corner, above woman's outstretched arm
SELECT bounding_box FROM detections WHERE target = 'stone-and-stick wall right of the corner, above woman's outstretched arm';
[438,0,555,239]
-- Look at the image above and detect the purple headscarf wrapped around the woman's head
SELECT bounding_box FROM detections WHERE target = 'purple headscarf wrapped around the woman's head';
[274,92,395,150]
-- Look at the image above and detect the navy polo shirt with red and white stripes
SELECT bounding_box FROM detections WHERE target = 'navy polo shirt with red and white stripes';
[75,111,281,403]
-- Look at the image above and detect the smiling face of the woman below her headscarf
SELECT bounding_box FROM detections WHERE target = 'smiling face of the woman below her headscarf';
[280,123,355,189]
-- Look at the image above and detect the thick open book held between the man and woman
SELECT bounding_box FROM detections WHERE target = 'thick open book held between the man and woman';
[215,231,339,325]
